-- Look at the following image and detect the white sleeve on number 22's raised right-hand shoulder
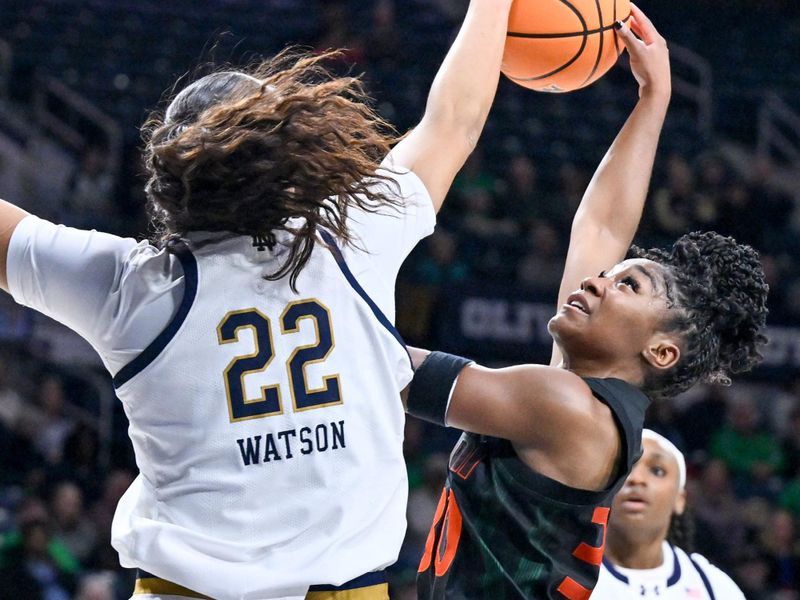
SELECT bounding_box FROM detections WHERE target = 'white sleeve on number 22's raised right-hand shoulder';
[348,169,436,287]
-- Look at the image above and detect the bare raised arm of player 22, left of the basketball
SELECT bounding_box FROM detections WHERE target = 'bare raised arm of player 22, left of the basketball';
[387,0,511,211]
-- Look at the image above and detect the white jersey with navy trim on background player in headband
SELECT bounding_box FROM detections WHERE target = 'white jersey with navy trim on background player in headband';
[590,542,744,600]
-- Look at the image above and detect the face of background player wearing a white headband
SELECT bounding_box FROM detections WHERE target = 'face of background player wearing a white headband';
[609,439,685,532]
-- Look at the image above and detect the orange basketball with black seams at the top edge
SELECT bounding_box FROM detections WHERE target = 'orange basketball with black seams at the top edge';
[502,0,630,92]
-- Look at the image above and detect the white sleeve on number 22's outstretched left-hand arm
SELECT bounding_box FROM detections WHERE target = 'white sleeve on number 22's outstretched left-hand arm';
[7,215,137,364]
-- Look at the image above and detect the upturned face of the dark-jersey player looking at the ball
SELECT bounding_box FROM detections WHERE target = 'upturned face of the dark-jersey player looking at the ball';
[548,258,668,362]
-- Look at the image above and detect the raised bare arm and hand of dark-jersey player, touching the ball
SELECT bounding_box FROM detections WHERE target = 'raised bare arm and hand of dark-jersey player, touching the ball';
[550,4,671,365]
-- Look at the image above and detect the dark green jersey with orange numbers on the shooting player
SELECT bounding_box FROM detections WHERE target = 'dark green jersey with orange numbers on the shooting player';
[417,378,649,600]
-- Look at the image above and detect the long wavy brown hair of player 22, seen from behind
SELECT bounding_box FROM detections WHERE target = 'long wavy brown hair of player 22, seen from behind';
[142,49,401,288]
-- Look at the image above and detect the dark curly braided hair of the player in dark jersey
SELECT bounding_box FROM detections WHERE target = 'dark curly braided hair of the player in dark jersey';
[631,232,769,399]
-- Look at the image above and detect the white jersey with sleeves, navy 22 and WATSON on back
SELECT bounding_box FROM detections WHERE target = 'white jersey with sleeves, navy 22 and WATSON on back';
[9,172,435,599]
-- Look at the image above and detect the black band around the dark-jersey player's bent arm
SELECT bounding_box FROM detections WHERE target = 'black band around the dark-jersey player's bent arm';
[407,352,473,425]
